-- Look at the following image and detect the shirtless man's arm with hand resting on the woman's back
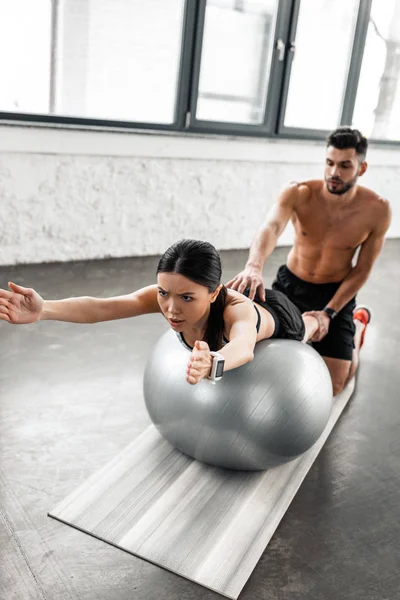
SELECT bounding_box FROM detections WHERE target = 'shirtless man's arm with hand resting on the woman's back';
[226,183,299,300]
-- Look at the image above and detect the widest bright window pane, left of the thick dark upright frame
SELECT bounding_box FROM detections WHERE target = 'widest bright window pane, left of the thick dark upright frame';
[55,0,185,123]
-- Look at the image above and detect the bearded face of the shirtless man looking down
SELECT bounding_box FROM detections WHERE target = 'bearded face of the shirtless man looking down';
[325,146,367,196]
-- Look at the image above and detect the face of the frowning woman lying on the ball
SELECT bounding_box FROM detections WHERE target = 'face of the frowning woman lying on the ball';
[157,273,220,331]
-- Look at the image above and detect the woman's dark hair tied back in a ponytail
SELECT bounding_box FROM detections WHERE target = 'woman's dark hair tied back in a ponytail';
[157,240,227,351]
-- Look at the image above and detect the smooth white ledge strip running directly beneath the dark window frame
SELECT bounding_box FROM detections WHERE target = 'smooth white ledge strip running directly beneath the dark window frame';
[0,123,400,167]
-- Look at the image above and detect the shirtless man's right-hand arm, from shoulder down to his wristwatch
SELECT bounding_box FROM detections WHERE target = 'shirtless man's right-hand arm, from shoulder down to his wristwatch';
[327,201,391,312]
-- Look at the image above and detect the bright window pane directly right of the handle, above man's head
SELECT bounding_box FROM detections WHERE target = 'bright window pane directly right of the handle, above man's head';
[284,0,358,130]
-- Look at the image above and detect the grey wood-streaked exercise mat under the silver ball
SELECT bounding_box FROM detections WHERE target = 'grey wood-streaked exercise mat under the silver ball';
[49,380,354,598]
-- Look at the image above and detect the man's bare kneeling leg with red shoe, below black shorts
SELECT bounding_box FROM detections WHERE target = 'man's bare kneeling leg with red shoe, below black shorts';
[322,307,371,396]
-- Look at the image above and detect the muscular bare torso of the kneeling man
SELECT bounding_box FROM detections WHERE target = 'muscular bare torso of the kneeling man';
[287,180,384,283]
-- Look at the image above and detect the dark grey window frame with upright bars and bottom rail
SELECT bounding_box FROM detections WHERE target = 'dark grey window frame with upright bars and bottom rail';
[0,0,400,146]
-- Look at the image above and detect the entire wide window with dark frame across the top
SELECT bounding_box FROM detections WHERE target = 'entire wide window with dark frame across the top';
[0,0,400,142]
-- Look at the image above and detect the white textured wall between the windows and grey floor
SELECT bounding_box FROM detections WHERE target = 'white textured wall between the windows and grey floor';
[0,126,400,265]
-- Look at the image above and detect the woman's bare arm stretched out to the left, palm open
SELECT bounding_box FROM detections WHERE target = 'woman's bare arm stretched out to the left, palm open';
[0,282,160,325]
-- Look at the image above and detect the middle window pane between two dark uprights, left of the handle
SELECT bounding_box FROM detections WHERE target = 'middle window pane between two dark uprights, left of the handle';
[196,0,278,124]
